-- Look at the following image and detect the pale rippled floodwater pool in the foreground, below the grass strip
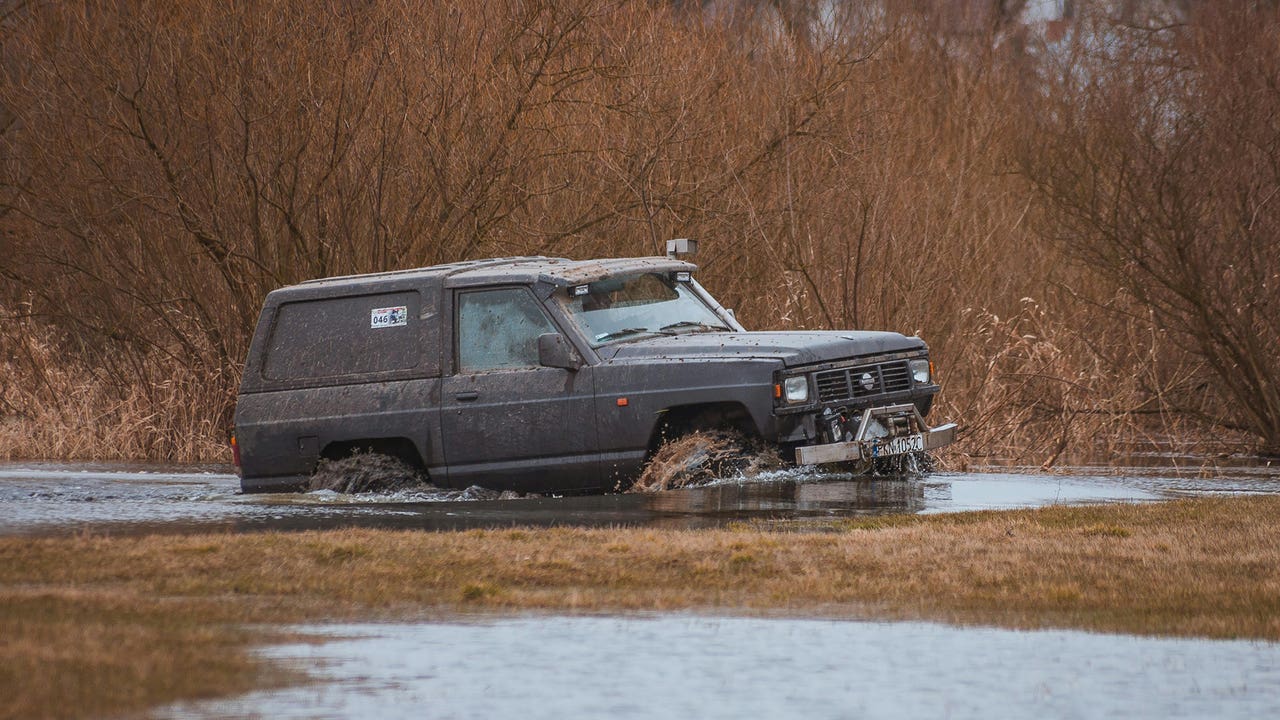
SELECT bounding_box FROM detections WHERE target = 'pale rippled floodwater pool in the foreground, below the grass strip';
[157,615,1280,720]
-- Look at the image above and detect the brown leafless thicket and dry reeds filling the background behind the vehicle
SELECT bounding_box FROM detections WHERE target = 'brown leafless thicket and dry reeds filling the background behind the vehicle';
[0,0,1280,465]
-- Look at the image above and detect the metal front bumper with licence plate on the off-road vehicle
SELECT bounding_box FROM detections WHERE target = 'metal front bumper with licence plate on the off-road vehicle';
[796,405,956,465]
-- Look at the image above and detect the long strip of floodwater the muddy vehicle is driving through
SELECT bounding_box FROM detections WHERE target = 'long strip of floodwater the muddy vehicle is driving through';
[0,462,1280,534]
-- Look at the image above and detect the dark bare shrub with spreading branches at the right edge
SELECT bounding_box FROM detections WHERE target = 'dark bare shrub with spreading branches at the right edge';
[1024,3,1280,452]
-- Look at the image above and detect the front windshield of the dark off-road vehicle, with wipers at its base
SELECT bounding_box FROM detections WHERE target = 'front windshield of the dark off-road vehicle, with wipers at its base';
[561,273,731,347]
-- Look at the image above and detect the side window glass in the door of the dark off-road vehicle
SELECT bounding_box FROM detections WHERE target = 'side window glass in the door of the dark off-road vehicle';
[457,287,559,373]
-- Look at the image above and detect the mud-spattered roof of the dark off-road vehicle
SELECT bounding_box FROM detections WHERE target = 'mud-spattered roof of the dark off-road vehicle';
[276,256,698,295]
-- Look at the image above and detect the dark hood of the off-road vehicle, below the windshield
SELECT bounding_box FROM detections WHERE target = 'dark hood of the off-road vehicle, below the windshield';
[598,331,925,368]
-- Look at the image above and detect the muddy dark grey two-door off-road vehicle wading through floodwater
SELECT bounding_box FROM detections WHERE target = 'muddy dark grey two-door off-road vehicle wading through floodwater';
[233,241,955,493]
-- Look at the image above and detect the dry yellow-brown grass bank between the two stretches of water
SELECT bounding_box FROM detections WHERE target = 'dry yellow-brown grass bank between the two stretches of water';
[0,497,1280,717]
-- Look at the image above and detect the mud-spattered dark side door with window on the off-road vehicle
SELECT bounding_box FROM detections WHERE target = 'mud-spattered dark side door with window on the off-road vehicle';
[440,286,600,492]
